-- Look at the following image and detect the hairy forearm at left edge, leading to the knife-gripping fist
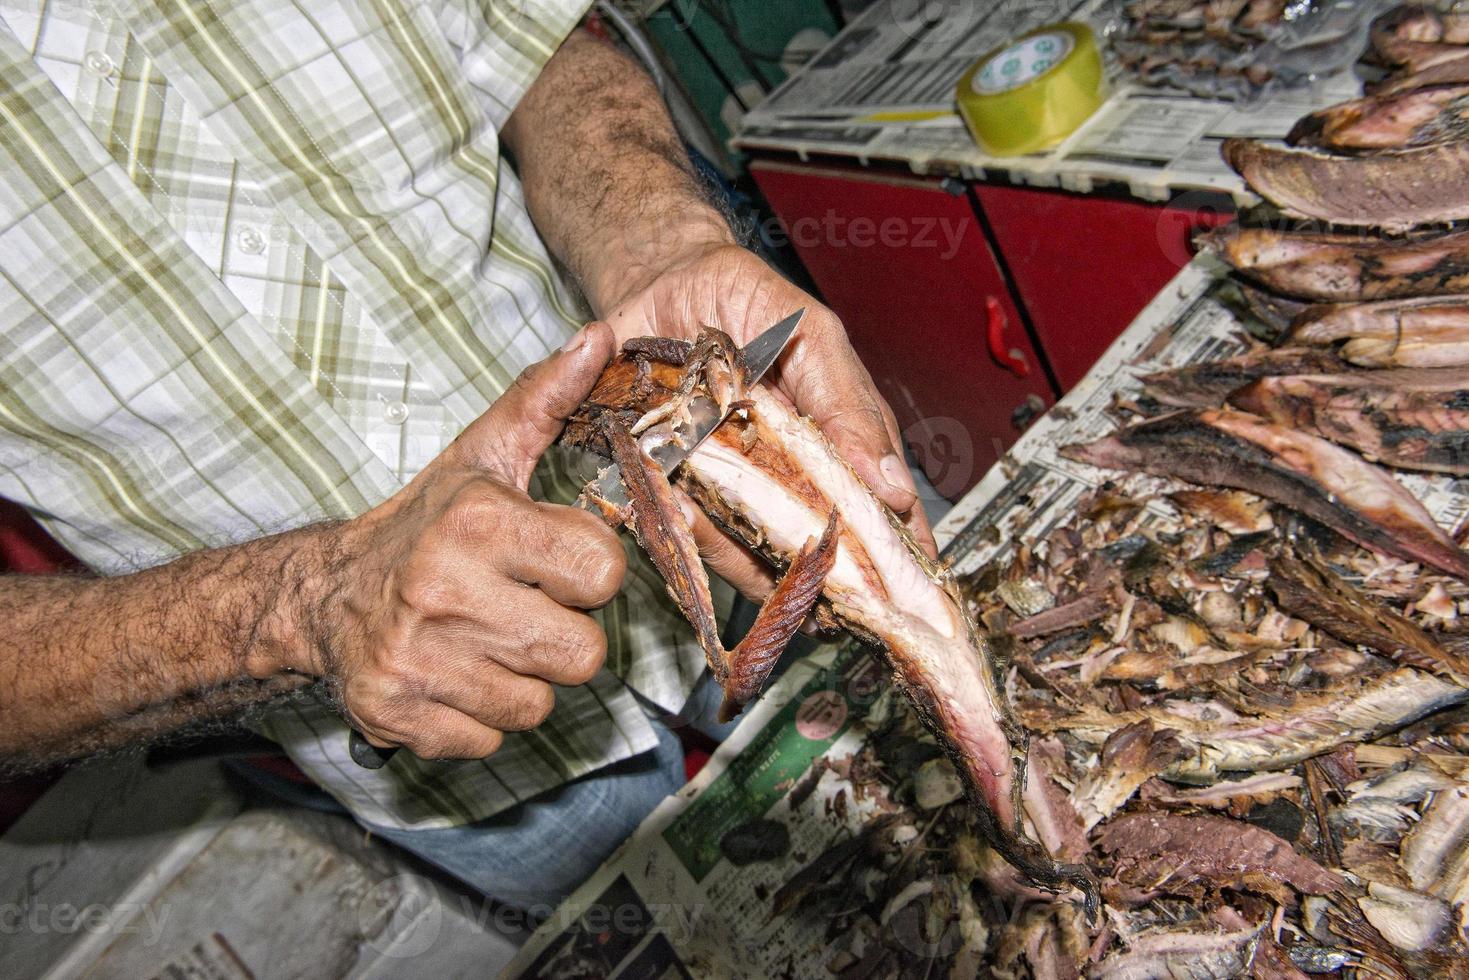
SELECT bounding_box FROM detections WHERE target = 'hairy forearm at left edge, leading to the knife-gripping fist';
[0,526,331,767]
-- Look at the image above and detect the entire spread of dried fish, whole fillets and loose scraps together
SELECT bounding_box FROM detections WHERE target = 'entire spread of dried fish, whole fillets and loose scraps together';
[774,1,1469,979]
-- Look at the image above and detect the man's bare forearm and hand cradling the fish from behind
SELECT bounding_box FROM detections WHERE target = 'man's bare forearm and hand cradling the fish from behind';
[502,31,934,598]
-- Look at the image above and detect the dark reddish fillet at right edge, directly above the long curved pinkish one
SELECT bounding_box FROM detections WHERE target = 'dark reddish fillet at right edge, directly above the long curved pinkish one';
[1230,367,1469,476]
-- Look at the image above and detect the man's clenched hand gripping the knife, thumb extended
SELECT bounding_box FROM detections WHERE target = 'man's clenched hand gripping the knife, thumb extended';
[301,325,624,758]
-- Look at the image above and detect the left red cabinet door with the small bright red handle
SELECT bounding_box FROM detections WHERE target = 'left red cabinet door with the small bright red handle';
[751,162,1052,498]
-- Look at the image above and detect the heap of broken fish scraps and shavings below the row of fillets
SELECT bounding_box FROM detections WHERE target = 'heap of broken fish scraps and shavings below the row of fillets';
[774,487,1469,979]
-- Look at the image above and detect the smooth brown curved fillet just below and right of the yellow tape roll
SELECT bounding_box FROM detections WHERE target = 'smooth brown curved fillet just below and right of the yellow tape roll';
[1221,138,1469,231]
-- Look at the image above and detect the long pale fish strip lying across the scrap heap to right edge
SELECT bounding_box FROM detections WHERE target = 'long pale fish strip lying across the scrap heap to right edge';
[1022,667,1469,786]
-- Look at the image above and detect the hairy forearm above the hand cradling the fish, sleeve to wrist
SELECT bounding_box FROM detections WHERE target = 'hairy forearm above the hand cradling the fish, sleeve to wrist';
[502,31,733,314]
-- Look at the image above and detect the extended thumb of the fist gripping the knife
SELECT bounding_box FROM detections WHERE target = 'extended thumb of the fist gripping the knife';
[454,322,617,489]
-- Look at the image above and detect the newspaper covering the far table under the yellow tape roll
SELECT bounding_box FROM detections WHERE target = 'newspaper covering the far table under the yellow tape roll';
[733,0,1385,206]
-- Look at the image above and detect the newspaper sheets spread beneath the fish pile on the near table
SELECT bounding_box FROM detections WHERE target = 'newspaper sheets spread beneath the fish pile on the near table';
[505,257,1469,980]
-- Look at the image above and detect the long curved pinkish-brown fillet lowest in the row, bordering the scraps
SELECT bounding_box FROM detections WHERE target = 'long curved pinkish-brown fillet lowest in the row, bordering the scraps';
[1061,408,1469,582]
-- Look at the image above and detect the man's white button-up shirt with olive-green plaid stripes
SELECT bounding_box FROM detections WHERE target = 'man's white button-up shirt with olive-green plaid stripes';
[0,0,727,829]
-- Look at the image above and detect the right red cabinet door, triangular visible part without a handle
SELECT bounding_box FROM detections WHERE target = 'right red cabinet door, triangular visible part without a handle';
[974,184,1232,391]
